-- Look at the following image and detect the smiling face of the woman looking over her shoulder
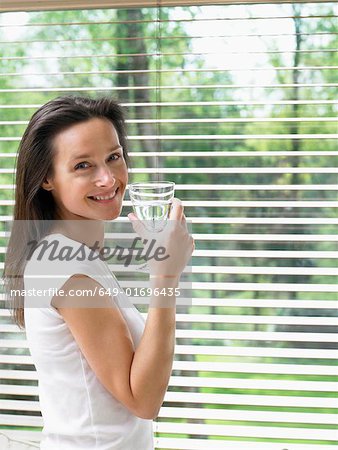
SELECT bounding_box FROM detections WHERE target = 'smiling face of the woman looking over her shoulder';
[42,118,128,220]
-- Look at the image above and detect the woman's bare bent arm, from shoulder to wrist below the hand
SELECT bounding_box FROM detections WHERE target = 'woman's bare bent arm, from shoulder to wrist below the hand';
[53,276,177,419]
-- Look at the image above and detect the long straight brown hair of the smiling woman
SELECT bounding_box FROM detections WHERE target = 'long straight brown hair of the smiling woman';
[3,96,130,328]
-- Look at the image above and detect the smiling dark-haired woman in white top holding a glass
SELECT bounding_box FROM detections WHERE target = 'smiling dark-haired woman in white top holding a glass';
[5,97,194,450]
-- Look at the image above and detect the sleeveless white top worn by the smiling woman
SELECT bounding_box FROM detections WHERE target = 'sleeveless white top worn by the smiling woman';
[24,234,154,450]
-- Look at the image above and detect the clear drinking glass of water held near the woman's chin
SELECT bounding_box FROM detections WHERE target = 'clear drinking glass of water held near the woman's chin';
[129,181,175,270]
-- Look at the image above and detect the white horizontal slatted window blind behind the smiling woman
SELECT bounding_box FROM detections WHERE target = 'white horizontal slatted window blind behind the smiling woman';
[0,2,338,450]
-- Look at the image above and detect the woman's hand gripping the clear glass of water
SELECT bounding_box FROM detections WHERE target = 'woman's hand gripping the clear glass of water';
[128,198,194,278]
